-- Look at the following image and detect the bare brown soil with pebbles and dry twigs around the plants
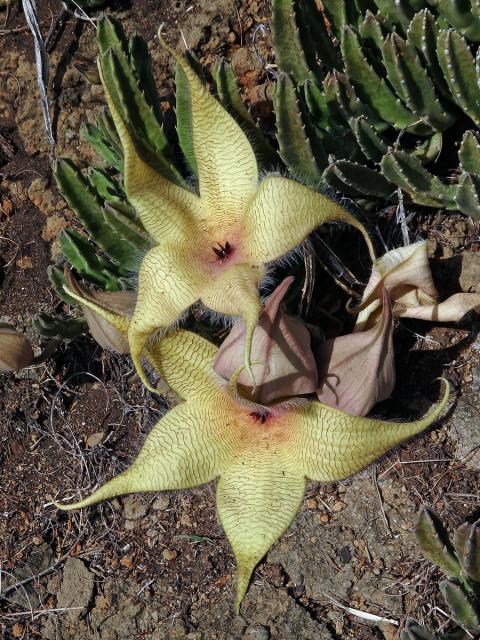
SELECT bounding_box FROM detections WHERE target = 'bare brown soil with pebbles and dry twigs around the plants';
[0,0,480,640]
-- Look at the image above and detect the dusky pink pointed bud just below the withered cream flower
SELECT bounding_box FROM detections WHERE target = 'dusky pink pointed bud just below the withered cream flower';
[315,290,395,416]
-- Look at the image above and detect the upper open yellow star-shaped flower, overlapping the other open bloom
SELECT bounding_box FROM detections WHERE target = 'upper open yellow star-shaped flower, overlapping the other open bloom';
[95,34,373,388]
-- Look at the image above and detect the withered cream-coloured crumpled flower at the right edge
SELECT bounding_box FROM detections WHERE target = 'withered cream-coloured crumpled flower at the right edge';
[351,241,480,331]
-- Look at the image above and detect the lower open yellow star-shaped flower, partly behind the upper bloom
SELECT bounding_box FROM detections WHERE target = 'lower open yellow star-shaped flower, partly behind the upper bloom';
[58,292,448,610]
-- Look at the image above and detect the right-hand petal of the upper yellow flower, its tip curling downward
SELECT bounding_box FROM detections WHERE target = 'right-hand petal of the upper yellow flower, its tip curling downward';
[244,176,375,264]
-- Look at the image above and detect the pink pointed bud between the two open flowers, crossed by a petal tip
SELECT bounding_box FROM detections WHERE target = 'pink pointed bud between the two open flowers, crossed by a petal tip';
[214,276,317,404]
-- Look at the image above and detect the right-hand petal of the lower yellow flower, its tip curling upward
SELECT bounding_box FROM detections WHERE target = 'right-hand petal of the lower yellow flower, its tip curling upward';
[290,378,449,482]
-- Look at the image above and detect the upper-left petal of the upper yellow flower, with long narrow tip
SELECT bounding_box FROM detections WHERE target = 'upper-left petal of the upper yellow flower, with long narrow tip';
[99,52,202,242]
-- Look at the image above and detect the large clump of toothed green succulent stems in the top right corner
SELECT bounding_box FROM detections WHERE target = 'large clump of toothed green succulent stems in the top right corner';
[271,0,480,219]
